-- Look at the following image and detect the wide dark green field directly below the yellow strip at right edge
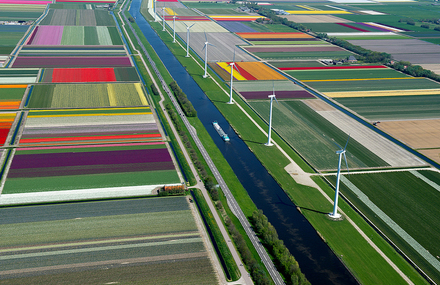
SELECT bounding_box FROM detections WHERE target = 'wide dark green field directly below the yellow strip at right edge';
[335,95,440,121]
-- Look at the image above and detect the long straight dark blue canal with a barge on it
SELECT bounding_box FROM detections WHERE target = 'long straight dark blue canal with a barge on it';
[130,0,357,284]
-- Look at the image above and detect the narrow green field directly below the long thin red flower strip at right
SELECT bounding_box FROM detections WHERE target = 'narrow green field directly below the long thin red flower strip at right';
[285,69,410,80]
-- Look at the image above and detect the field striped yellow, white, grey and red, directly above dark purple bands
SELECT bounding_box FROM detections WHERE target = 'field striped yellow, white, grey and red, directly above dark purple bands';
[19,107,163,147]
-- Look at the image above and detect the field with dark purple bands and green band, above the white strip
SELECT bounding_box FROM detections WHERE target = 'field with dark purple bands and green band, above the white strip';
[2,143,180,194]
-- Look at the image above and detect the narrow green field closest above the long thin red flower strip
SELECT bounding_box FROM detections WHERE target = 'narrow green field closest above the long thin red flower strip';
[254,51,352,59]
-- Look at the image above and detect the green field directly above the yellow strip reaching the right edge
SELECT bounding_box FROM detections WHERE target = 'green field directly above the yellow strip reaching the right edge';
[307,78,440,92]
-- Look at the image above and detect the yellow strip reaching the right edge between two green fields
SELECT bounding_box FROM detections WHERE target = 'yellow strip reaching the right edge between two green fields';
[323,89,440,98]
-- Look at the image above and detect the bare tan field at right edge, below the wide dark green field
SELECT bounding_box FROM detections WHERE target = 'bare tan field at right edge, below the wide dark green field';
[377,120,440,149]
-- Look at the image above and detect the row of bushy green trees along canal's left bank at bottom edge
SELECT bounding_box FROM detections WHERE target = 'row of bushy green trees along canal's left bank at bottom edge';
[251,210,310,285]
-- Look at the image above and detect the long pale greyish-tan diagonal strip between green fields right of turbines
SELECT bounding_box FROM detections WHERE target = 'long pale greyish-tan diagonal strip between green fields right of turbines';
[305,100,426,167]
